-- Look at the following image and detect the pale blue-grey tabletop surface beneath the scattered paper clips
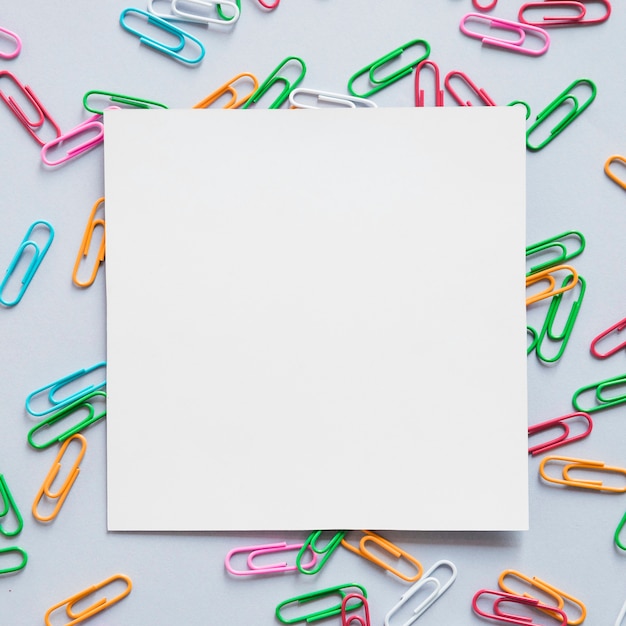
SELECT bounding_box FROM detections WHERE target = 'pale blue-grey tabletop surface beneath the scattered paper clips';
[0,0,626,626]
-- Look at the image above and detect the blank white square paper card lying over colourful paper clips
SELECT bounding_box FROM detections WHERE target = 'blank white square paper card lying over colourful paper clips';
[105,107,528,531]
